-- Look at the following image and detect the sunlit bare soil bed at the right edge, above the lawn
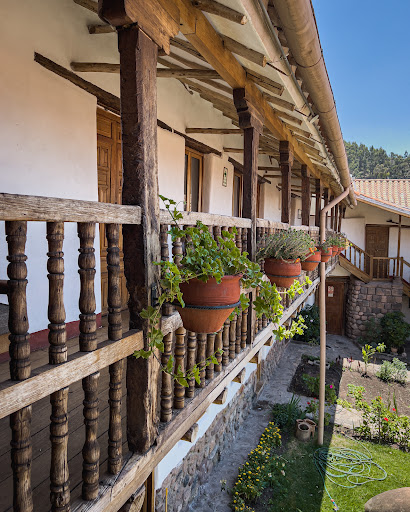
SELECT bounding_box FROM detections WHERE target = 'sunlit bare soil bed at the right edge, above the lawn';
[338,369,410,416]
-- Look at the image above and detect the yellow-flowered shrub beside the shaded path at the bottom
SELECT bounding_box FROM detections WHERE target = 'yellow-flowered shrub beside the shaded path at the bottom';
[231,422,285,512]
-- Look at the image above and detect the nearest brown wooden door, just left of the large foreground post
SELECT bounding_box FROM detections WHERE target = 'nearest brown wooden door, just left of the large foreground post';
[97,110,128,315]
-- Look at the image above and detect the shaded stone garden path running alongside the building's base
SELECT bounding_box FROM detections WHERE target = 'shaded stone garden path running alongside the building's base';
[187,335,361,512]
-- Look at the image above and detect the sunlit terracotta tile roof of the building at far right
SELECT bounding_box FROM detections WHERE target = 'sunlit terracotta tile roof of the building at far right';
[354,179,410,210]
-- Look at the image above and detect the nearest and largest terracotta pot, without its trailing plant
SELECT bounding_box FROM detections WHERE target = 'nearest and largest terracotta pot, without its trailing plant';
[175,275,242,333]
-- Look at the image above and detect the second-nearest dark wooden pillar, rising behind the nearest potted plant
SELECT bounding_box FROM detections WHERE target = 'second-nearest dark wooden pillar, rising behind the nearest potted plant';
[233,89,264,343]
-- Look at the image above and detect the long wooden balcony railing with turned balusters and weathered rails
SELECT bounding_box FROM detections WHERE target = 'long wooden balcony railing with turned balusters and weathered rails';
[0,194,335,512]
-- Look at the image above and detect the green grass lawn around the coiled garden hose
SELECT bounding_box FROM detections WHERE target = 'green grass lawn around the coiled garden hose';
[270,434,410,512]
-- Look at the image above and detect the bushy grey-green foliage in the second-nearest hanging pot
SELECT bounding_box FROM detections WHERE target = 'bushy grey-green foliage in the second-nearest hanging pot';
[256,229,315,261]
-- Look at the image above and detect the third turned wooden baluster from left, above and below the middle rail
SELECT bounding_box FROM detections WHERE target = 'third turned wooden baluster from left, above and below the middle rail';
[78,222,100,500]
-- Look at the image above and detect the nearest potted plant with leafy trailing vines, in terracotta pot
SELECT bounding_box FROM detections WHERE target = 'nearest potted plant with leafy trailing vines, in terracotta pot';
[134,196,311,386]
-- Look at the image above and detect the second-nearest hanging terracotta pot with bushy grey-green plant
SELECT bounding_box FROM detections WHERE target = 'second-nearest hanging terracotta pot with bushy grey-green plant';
[257,229,314,288]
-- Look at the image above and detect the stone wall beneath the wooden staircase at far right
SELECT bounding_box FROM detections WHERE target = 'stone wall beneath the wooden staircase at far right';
[346,276,403,339]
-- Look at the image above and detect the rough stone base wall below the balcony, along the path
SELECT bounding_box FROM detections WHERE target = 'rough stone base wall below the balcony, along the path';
[155,341,288,512]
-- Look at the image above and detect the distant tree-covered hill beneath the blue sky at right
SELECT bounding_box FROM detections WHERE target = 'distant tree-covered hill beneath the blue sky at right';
[345,141,410,179]
